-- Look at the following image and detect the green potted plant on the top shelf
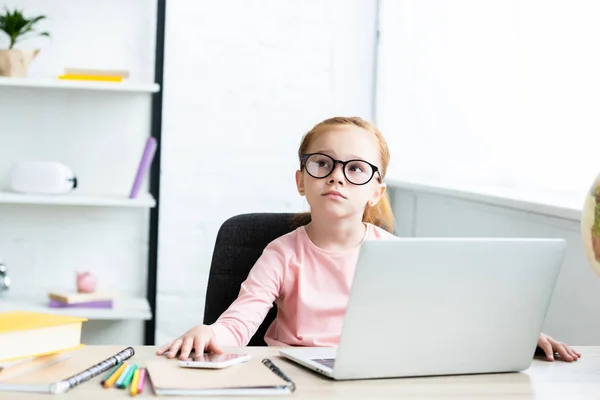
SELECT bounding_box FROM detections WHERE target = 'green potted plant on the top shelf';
[0,7,50,77]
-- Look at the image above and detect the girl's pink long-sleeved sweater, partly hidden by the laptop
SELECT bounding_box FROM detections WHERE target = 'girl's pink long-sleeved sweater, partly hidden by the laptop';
[212,224,395,346]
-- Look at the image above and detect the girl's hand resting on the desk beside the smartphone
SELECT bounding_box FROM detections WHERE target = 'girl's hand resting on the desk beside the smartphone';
[156,325,223,360]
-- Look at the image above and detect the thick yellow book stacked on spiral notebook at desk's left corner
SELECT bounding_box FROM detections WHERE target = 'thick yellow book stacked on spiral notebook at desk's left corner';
[0,311,137,399]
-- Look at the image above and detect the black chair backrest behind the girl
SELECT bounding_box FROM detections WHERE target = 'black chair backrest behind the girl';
[204,213,299,346]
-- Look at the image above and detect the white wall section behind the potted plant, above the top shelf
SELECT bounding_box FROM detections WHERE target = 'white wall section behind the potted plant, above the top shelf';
[0,0,156,82]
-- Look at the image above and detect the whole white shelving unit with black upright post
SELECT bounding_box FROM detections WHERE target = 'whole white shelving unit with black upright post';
[0,0,166,345]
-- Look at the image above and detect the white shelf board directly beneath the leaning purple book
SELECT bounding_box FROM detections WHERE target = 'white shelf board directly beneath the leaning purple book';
[0,192,156,208]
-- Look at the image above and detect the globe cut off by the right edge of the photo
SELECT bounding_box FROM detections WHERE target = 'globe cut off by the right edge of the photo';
[581,174,600,276]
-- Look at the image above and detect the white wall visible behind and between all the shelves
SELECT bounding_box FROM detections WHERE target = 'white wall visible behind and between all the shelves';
[0,0,156,344]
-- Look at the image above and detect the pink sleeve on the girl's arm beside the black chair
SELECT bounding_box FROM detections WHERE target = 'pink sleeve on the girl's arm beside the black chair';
[211,243,286,346]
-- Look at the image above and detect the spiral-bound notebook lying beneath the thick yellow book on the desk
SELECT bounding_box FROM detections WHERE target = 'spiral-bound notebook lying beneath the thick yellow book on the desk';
[0,346,135,394]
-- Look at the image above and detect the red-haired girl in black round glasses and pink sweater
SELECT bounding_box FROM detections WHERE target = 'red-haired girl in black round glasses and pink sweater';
[157,117,580,361]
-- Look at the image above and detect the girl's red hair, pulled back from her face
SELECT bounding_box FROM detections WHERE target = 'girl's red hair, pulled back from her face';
[295,117,394,233]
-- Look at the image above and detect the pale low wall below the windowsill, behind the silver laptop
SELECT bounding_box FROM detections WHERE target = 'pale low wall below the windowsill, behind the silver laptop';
[392,184,600,346]
